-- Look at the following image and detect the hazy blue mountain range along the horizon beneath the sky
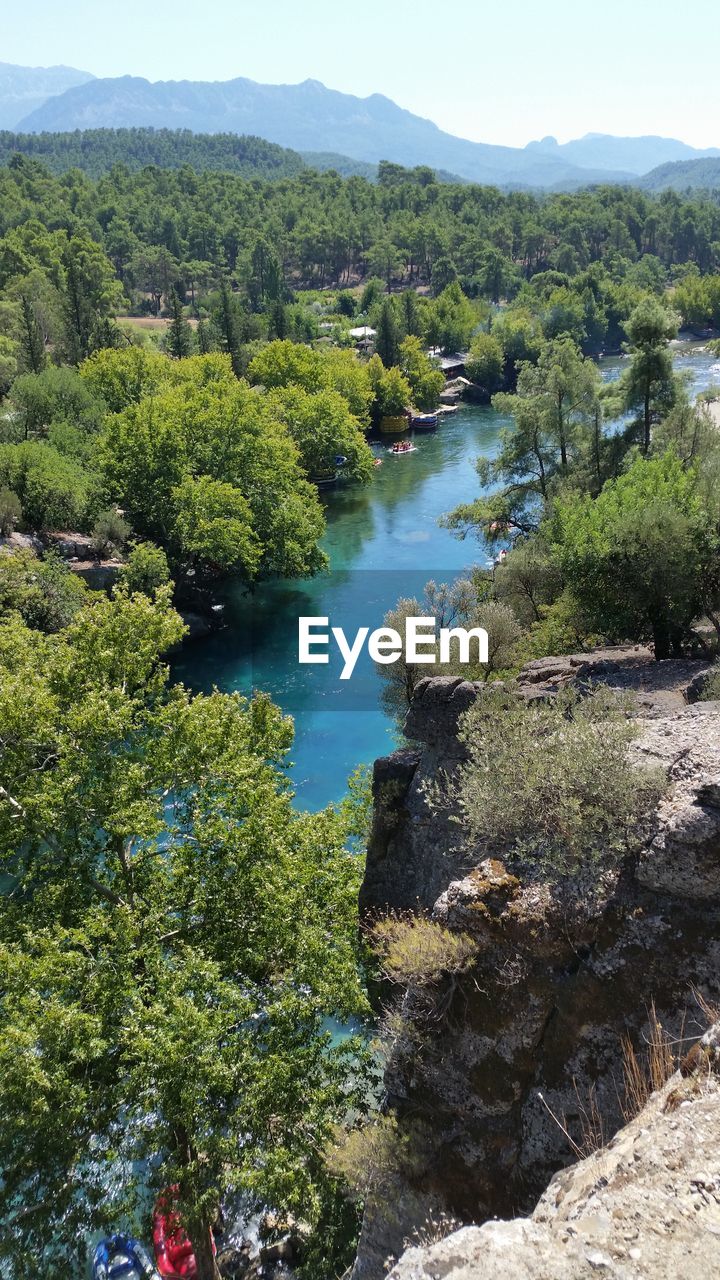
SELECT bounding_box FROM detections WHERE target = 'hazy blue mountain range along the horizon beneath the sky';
[0,64,720,189]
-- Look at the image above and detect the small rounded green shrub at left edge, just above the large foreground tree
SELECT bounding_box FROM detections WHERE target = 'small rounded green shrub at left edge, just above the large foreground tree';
[0,550,87,631]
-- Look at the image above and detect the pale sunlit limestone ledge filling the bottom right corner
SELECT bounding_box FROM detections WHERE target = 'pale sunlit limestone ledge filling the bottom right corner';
[391,1059,720,1280]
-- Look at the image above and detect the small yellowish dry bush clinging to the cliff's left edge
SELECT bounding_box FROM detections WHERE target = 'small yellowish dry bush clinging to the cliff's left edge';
[372,915,478,987]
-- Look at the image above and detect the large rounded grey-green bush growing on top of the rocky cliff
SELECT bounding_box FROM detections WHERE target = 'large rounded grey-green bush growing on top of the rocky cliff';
[454,687,665,874]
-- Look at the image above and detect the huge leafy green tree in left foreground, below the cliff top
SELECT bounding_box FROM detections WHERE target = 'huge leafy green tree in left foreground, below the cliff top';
[0,589,366,1280]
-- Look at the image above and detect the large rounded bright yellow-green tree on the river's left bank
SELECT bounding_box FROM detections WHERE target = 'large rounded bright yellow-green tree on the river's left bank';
[101,356,324,576]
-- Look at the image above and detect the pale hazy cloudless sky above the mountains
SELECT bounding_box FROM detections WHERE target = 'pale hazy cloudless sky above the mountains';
[0,0,720,146]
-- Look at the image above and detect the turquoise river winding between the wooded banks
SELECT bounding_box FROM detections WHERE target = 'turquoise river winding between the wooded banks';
[174,343,720,809]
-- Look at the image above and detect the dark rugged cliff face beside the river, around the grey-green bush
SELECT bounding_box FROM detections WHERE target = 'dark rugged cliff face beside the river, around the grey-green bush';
[355,648,720,1280]
